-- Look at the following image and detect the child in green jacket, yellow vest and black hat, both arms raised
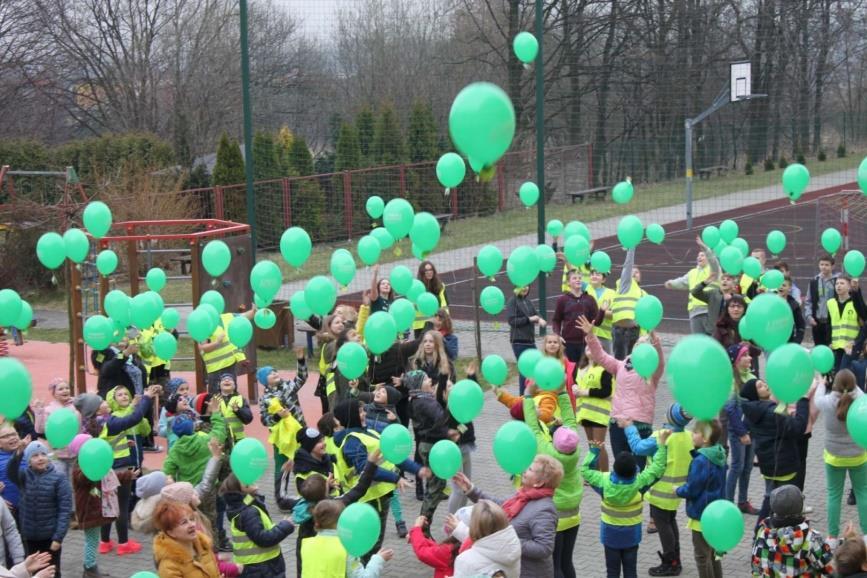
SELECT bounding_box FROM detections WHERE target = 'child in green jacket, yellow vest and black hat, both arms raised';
[581,430,671,576]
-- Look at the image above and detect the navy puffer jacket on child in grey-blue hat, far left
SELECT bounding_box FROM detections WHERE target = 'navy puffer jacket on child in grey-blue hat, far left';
[8,452,72,542]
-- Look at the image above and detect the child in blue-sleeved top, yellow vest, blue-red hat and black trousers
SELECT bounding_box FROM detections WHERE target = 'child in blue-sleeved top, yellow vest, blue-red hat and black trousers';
[621,403,693,576]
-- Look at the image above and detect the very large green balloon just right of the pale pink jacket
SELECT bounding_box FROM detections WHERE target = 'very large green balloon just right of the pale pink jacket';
[666,332,736,419]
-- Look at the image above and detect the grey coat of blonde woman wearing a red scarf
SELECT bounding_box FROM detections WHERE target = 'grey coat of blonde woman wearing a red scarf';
[467,487,557,578]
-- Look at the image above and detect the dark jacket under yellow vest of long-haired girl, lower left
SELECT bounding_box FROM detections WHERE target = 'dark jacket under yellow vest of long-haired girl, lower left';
[223,492,295,578]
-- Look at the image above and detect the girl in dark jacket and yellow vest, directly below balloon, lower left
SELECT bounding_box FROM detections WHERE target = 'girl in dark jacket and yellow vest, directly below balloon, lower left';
[220,474,295,578]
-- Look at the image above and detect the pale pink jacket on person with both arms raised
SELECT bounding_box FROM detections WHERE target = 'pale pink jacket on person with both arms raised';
[587,335,665,423]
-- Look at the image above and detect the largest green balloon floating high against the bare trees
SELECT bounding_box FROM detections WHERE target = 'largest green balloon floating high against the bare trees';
[449,82,515,167]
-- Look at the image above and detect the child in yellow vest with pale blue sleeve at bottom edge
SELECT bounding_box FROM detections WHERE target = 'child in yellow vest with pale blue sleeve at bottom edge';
[298,500,394,578]
